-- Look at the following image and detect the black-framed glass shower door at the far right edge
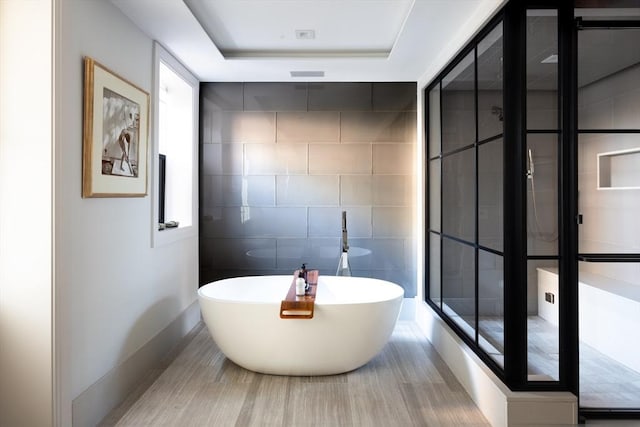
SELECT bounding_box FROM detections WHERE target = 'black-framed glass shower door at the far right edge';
[575,8,640,415]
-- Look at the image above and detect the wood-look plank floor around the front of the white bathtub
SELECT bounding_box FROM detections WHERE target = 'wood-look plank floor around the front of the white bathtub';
[100,321,489,427]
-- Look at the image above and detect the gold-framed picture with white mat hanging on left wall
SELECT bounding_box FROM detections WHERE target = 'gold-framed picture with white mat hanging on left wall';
[82,57,149,197]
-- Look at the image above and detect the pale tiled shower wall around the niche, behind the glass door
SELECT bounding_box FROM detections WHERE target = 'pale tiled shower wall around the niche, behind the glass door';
[578,65,640,286]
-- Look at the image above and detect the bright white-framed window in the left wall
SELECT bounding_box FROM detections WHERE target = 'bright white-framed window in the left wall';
[152,44,199,246]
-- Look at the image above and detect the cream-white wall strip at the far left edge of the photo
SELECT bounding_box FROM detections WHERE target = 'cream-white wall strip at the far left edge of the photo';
[0,0,53,426]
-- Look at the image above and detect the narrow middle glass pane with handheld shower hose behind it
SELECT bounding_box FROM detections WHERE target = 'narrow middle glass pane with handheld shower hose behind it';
[526,134,558,255]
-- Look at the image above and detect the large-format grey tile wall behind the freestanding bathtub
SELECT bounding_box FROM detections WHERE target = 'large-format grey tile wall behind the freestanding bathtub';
[200,83,422,297]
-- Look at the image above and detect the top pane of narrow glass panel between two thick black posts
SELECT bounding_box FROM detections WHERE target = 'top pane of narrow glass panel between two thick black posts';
[527,9,558,129]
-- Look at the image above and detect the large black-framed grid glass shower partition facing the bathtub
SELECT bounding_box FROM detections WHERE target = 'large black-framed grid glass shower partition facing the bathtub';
[427,21,504,370]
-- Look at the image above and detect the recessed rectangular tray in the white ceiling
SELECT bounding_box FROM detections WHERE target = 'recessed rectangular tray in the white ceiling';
[182,0,412,59]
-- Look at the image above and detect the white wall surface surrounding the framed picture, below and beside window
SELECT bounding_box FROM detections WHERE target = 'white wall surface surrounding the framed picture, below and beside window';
[55,0,198,424]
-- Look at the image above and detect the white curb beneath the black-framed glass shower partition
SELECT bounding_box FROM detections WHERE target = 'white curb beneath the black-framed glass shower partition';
[415,301,578,427]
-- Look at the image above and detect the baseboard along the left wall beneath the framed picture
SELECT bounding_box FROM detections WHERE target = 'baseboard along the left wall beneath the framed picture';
[71,300,200,427]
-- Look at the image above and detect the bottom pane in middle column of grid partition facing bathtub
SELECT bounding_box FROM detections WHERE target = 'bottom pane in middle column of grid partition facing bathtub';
[442,238,476,338]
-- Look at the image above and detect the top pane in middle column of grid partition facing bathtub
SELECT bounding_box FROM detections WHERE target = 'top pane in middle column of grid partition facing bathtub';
[440,52,476,153]
